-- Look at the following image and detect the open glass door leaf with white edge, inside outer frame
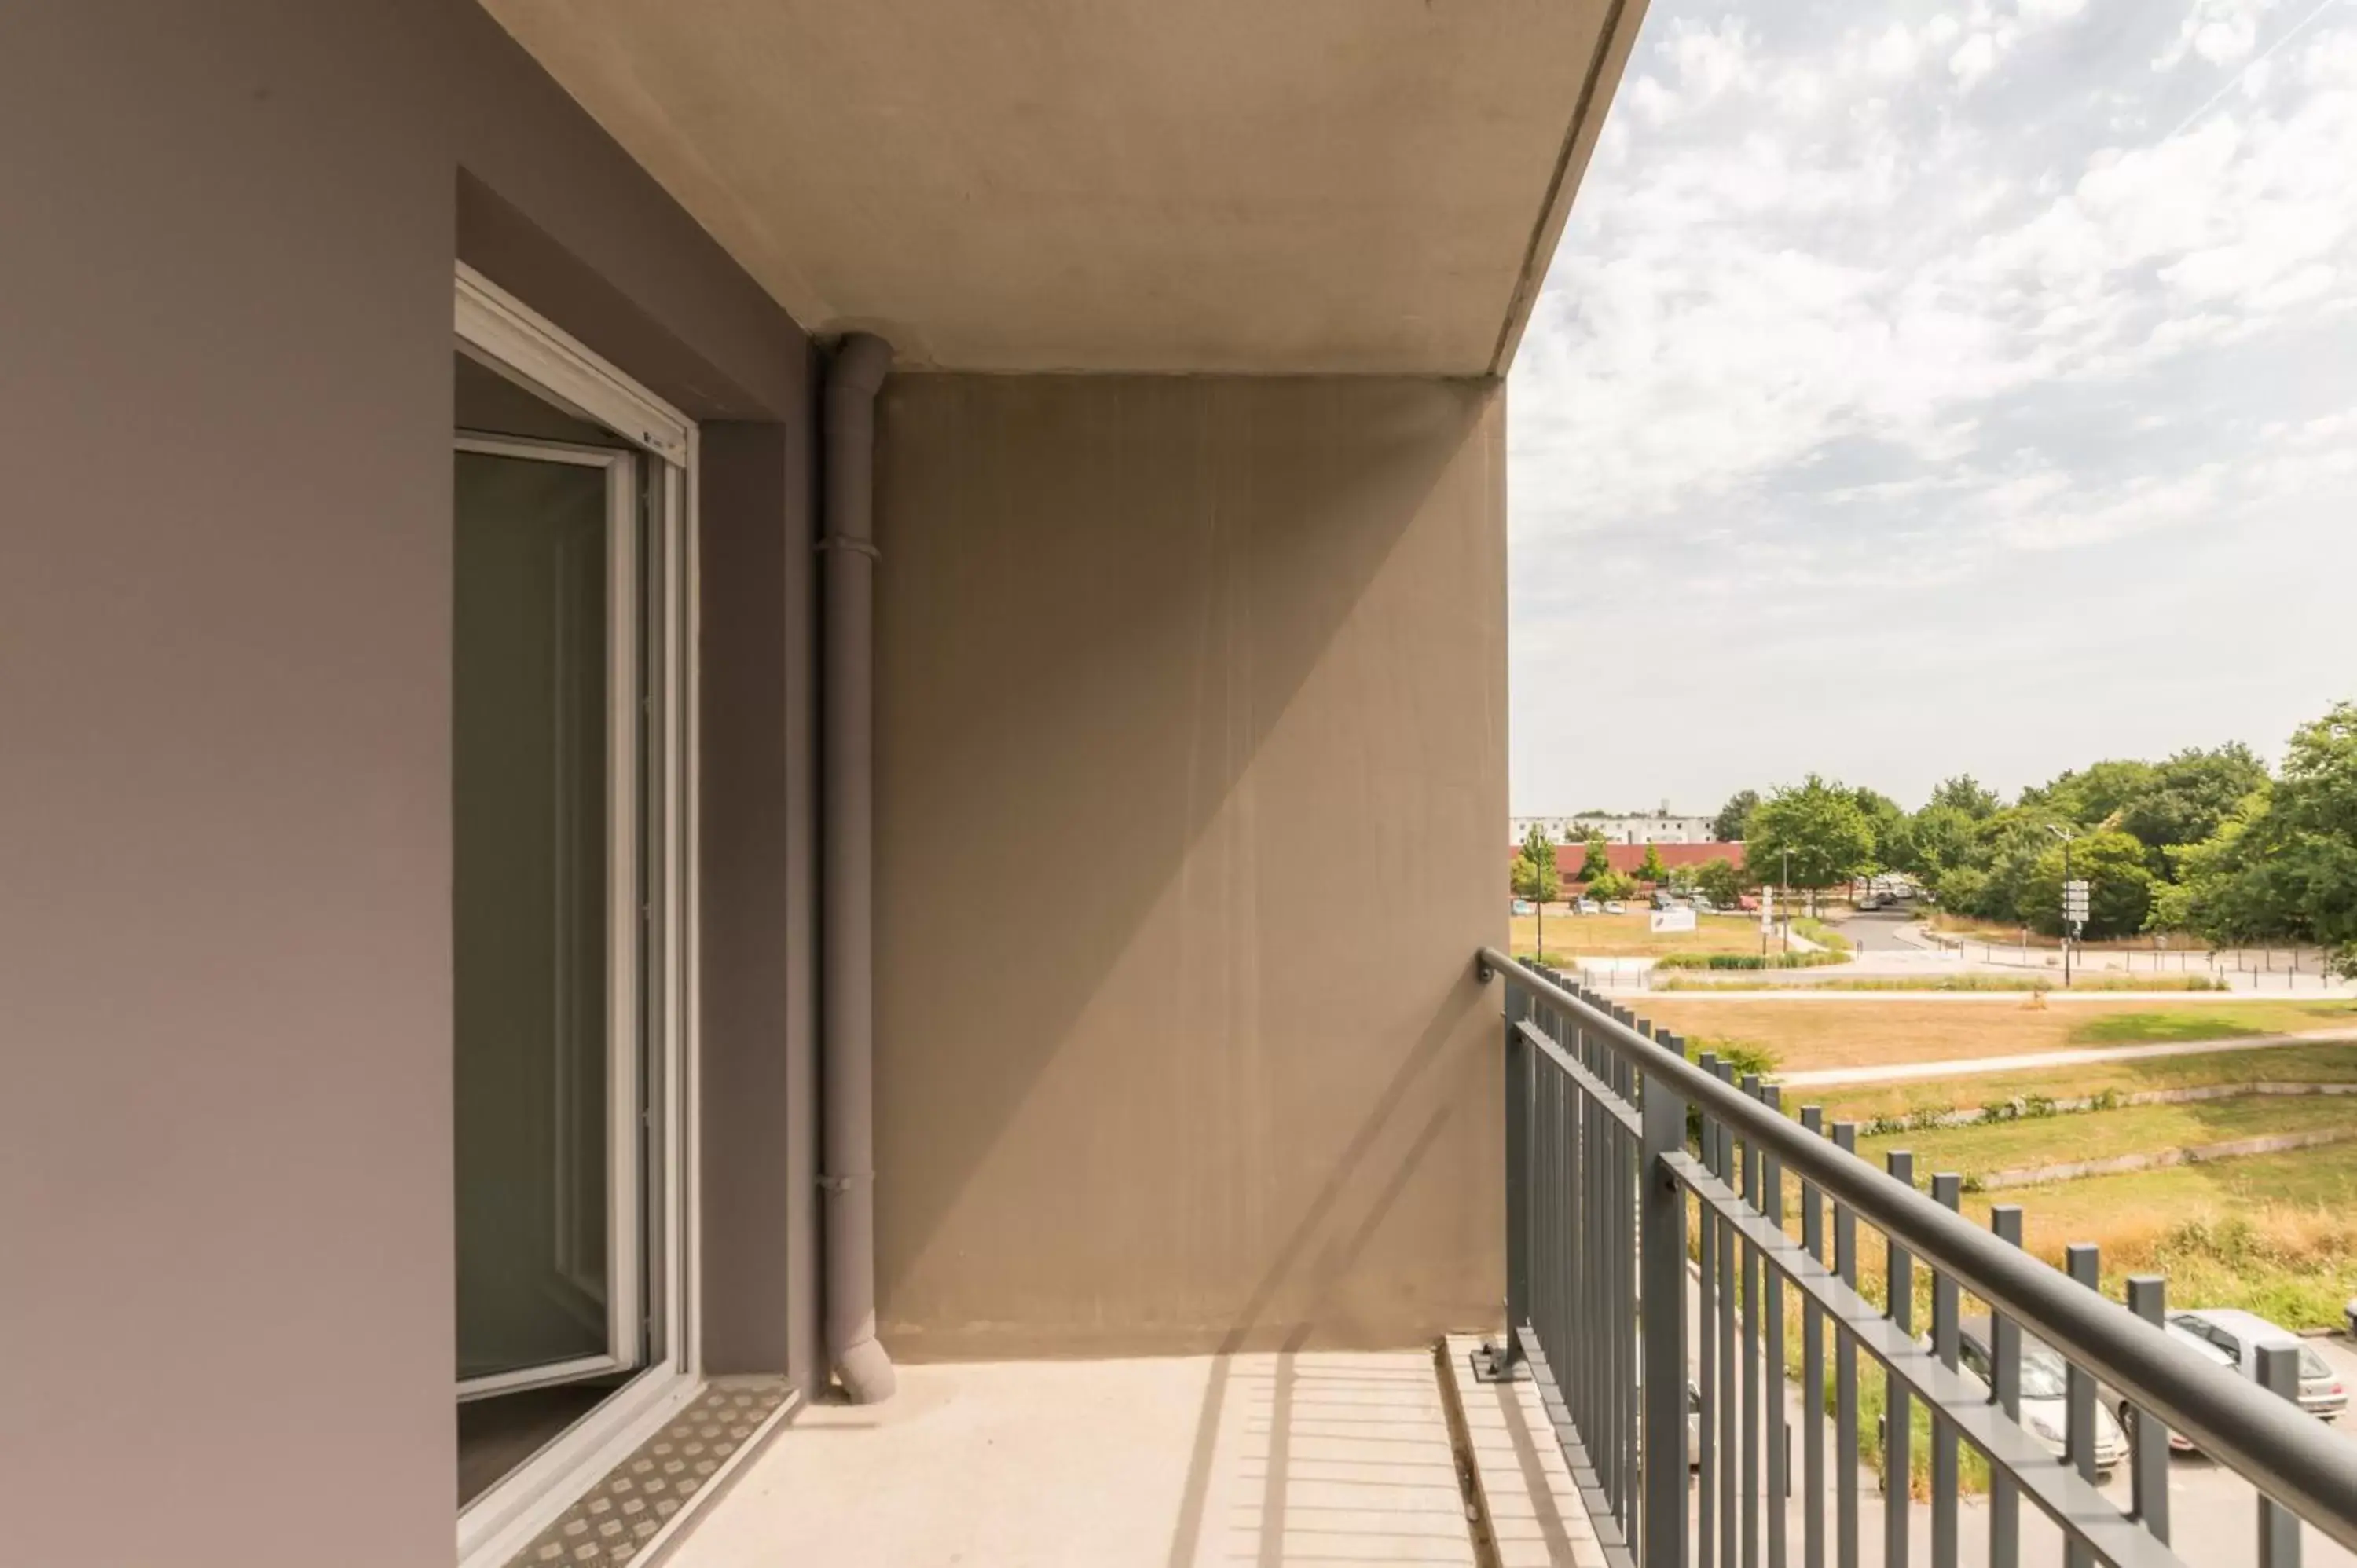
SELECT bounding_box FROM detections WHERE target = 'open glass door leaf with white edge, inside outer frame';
[450,438,641,1396]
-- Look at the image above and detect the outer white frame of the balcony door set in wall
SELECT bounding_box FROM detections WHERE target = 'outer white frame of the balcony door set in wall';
[453,262,702,1568]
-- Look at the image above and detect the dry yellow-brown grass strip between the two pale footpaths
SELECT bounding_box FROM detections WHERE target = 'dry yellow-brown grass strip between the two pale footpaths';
[1638,993,2357,1073]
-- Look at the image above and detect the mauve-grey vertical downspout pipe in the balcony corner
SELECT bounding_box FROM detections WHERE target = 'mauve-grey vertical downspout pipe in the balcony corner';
[818,332,898,1405]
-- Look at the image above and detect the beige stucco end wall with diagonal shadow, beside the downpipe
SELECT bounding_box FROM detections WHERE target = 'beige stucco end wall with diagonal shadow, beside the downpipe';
[877,375,1506,1358]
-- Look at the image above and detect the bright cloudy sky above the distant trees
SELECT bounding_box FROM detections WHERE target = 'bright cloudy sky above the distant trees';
[1508,0,2357,814]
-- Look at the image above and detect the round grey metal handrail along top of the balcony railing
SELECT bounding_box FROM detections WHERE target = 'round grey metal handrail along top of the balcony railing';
[1480,946,2357,1552]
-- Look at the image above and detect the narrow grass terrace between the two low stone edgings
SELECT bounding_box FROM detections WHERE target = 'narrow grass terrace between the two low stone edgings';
[1857,1094,2357,1181]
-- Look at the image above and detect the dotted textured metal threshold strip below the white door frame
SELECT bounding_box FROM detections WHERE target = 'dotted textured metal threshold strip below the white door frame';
[509,1377,794,1568]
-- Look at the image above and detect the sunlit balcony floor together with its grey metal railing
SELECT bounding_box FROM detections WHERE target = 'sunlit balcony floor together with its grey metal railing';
[507,951,2357,1568]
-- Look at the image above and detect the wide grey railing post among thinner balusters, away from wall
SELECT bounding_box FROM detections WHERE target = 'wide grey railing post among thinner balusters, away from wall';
[1638,1035,1685,1568]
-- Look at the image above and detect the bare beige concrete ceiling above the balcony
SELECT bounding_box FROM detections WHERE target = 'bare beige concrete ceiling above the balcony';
[469,0,1643,375]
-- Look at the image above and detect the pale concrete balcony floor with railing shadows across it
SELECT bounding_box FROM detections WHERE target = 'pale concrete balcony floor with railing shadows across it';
[669,1351,1475,1568]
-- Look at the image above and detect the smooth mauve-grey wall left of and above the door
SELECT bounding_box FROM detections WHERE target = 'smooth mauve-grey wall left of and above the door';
[0,0,806,1568]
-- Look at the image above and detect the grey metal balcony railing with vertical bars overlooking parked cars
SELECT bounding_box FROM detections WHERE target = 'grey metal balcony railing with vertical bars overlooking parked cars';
[1480,948,2357,1568]
